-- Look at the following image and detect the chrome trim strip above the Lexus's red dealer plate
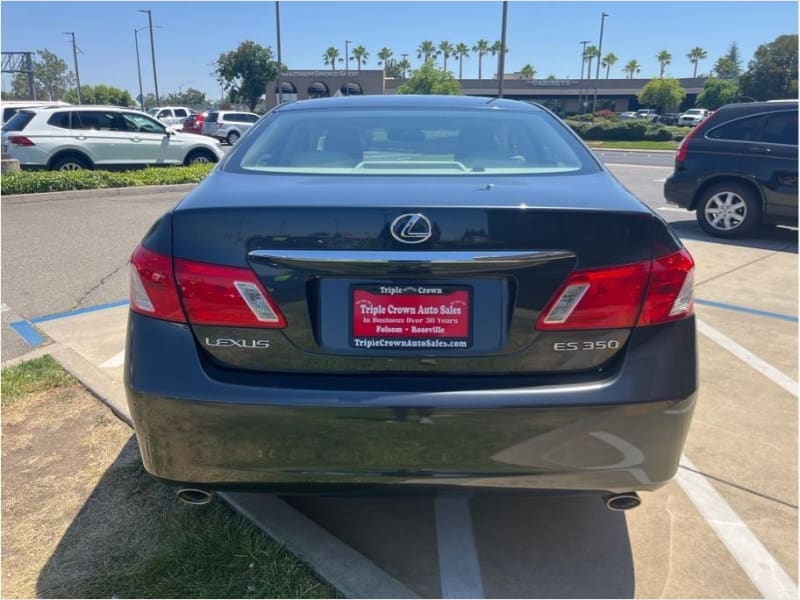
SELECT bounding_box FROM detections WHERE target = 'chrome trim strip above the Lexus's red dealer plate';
[248,250,575,274]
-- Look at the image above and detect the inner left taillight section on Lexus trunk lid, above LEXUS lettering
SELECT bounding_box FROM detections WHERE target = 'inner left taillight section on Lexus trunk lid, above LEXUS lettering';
[175,258,286,328]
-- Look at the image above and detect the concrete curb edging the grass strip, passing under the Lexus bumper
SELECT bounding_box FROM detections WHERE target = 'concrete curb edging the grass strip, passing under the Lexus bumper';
[38,343,419,598]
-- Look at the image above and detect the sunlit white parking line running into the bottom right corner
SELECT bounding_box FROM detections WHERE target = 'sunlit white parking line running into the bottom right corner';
[675,456,797,600]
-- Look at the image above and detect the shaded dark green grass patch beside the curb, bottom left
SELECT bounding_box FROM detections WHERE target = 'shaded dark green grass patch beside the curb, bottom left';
[81,500,339,598]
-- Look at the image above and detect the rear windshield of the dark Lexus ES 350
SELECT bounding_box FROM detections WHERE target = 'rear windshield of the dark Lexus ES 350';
[229,109,597,175]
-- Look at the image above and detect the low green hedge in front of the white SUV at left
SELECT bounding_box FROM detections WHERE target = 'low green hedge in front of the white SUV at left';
[0,163,214,194]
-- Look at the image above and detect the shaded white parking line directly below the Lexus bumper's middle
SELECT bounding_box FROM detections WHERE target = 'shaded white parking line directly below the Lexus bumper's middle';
[435,492,484,598]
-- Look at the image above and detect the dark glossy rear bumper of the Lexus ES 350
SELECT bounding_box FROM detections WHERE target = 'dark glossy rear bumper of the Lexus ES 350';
[125,314,697,492]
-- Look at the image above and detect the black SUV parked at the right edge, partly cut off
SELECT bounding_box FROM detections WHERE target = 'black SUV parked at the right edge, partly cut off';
[664,100,798,238]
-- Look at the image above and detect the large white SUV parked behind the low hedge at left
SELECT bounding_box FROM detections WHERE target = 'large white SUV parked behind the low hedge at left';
[2,106,223,170]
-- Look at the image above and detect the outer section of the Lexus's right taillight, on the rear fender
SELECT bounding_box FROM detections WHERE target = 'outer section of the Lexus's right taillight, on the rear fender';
[637,249,694,325]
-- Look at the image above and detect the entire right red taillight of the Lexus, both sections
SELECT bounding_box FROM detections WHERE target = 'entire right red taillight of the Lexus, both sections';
[536,249,694,331]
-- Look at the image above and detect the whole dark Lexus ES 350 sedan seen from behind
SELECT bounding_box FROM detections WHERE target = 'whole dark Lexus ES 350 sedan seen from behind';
[125,96,697,509]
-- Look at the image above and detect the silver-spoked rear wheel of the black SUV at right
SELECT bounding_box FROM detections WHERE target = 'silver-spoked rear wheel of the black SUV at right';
[696,182,761,238]
